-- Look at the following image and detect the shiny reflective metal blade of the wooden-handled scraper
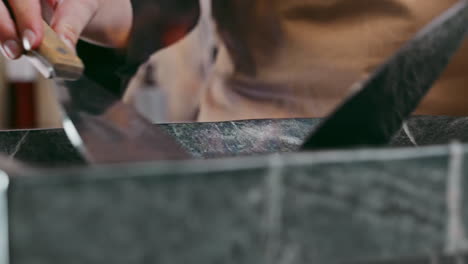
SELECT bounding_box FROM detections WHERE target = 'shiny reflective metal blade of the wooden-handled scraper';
[52,74,190,163]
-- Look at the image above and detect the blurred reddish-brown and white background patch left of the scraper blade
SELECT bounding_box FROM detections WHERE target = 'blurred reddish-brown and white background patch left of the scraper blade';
[0,55,61,129]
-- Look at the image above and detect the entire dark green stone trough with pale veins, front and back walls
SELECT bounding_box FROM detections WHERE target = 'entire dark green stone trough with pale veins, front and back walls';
[0,117,468,264]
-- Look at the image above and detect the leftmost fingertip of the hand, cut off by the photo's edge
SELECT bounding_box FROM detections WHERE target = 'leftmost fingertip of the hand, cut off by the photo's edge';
[0,2,22,59]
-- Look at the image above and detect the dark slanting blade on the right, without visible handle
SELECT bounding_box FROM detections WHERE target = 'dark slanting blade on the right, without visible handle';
[303,0,468,150]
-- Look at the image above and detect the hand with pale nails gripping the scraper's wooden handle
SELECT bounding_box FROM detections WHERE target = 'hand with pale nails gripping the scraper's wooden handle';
[0,0,132,59]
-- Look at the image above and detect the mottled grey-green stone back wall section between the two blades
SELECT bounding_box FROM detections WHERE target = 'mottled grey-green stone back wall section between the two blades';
[162,119,320,158]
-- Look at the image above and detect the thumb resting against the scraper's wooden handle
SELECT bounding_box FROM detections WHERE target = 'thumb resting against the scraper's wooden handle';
[51,0,99,49]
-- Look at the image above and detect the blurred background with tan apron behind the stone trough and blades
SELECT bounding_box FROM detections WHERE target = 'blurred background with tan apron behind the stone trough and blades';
[0,0,468,129]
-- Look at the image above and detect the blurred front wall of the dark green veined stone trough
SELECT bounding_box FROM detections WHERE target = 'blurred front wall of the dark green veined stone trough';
[9,144,458,264]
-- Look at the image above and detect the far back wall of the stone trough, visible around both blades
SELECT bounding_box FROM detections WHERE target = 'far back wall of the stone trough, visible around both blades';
[0,116,468,167]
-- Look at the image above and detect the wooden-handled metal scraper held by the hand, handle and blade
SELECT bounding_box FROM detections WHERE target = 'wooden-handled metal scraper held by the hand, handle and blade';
[26,23,190,164]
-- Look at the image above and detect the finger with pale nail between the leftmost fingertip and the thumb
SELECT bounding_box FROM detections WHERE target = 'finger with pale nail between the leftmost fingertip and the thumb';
[9,0,44,50]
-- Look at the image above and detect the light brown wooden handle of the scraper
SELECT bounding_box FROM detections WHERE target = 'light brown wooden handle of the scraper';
[37,22,84,79]
